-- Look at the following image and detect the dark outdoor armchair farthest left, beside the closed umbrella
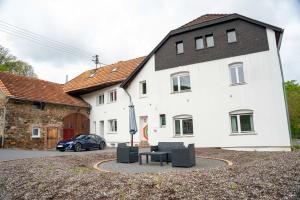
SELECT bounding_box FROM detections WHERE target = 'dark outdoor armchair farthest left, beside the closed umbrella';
[117,143,139,163]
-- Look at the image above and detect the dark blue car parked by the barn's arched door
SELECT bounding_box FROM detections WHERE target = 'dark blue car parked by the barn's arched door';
[56,134,106,152]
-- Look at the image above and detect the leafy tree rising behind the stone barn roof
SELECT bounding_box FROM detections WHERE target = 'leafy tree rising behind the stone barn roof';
[0,46,37,77]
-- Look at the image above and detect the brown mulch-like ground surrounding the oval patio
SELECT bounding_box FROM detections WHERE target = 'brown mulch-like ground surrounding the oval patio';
[0,149,300,200]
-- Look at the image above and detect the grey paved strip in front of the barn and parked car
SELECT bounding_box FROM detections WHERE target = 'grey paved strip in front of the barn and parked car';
[0,148,116,161]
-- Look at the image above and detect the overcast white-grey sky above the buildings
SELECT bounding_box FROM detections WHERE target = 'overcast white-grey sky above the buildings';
[0,0,300,83]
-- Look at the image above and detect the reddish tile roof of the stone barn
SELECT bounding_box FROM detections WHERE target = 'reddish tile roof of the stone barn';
[0,72,89,107]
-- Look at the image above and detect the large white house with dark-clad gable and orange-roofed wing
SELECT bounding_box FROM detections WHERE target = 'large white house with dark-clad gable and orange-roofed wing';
[65,14,291,151]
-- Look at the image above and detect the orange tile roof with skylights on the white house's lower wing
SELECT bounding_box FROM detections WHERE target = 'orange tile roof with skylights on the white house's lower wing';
[64,57,145,92]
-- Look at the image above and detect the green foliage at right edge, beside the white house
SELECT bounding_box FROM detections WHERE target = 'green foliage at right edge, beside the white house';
[285,80,300,139]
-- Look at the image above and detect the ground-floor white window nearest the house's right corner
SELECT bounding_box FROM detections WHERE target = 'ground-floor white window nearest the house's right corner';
[229,110,254,134]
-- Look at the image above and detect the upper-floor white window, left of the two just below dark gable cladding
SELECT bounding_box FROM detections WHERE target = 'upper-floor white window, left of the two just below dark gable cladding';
[171,72,191,92]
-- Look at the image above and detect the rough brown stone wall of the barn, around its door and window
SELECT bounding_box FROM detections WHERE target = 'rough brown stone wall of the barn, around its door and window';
[0,99,89,149]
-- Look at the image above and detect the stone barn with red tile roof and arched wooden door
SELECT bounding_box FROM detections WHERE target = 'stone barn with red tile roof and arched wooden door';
[0,72,90,149]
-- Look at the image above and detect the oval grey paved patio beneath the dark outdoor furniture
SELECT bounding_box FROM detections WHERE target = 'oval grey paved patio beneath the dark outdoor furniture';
[98,158,227,174]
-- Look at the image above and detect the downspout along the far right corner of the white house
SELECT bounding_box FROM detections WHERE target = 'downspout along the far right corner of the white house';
[277,33,292,146]
